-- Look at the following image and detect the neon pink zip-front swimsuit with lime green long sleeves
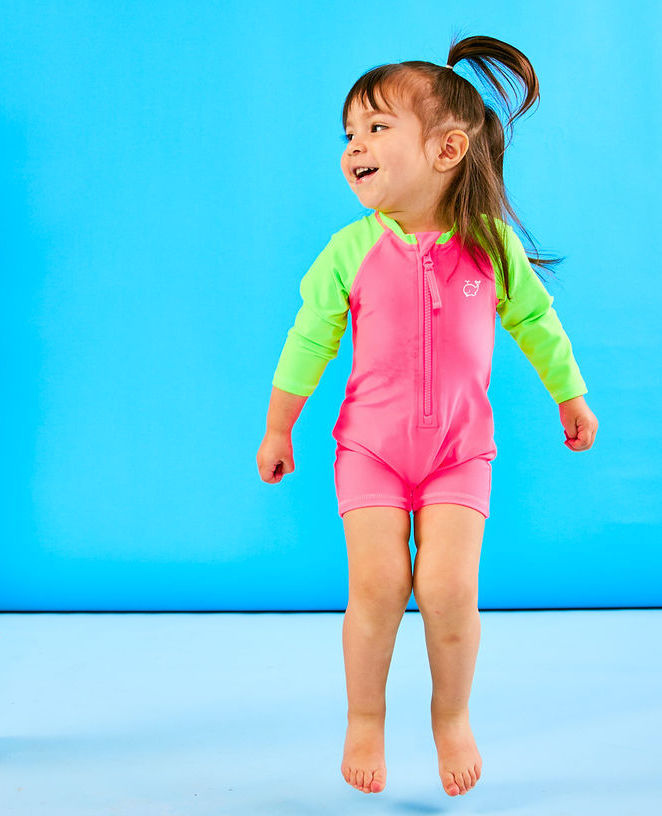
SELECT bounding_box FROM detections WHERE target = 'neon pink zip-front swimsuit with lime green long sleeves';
[273,211,587,517]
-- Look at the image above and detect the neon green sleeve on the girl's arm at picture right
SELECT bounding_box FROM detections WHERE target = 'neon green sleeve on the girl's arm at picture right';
[496,224,588,404]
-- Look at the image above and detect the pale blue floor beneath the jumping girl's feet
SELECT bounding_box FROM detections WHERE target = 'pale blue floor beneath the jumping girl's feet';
[0,610,662,816]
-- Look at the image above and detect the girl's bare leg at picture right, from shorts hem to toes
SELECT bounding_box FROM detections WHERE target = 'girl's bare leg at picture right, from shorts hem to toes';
[413,504,485,796]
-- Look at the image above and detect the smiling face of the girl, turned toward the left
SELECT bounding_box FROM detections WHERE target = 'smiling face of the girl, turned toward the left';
[340,94,440,212]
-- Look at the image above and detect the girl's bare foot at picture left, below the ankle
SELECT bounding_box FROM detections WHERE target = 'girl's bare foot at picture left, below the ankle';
[340,714,386,793]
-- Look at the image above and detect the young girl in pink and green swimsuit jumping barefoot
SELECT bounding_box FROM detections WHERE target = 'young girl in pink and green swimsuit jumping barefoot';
[257,37,598,796]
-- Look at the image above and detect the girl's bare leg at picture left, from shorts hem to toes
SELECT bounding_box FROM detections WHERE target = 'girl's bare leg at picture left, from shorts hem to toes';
[340,507,412,793]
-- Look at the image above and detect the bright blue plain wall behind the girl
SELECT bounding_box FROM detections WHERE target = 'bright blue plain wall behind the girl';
[0,0,662,610]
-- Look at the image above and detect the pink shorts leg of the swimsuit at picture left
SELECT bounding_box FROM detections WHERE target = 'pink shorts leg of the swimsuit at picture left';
[334,445,411,517]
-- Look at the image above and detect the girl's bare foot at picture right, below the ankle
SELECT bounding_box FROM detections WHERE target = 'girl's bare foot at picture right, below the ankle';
[432,703,483,796]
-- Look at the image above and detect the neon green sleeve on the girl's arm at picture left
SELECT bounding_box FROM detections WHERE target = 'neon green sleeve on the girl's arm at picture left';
[272,236,349,396]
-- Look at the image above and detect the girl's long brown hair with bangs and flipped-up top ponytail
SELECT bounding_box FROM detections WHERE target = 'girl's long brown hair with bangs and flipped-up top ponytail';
[342,35,563,298]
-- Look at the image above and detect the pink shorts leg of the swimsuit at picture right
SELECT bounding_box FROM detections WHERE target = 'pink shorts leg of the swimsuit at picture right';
[412,459,492,518]
